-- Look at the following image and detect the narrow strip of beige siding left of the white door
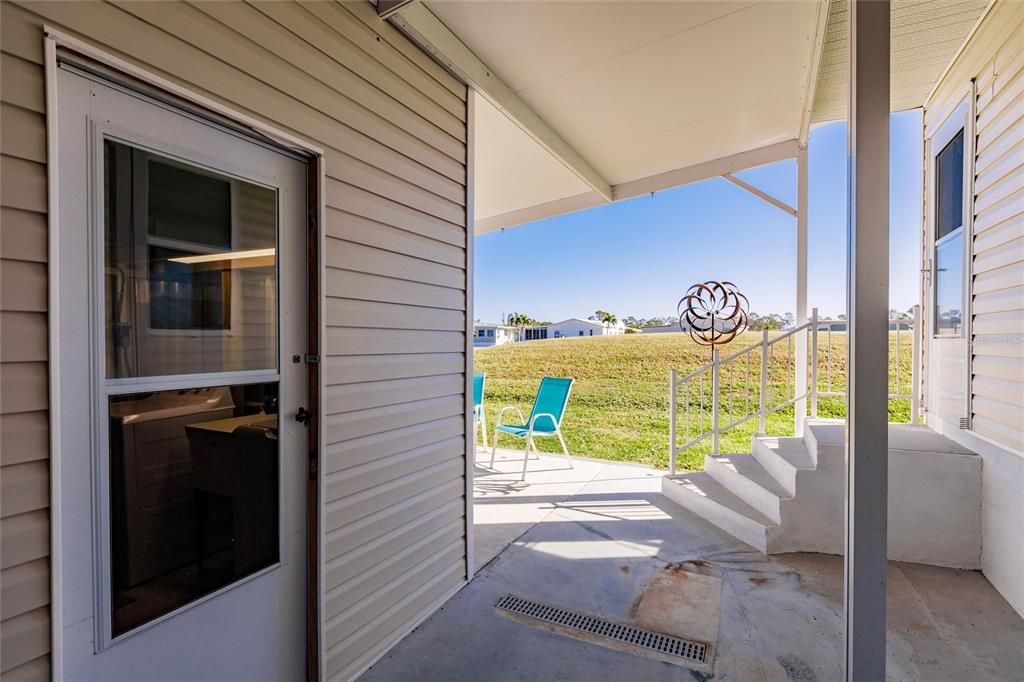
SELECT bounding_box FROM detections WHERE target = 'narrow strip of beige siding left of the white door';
[0,5,50,680]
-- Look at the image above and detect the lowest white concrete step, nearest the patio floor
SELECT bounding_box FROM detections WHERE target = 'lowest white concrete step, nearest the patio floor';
[662,472,775,552]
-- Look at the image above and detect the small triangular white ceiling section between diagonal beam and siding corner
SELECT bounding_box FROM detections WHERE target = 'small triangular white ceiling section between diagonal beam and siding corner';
[470,92,600,220]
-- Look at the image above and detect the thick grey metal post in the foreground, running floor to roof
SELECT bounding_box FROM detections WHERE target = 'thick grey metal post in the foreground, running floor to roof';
[844,0,891,682]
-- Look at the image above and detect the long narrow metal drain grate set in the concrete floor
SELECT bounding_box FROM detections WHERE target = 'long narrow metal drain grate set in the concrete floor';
[495,594,708,664]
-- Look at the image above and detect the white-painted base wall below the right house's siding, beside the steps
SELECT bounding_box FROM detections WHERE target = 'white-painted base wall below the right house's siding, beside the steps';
[929,417,1024,616]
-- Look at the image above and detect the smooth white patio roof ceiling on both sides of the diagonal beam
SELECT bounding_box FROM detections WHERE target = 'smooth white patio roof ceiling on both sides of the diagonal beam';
[426,0,819,232]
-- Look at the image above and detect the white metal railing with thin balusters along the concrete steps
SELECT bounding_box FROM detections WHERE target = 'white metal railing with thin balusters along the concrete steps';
[669,306,921,474]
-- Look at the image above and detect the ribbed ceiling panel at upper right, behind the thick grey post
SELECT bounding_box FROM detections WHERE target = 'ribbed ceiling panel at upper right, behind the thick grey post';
[811,0,989,123]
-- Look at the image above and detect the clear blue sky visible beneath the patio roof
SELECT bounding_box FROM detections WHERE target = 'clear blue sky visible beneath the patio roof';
[474,111,922,322]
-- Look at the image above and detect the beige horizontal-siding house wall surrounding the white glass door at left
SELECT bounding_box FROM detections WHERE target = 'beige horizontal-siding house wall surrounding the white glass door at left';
[0,2,468,679]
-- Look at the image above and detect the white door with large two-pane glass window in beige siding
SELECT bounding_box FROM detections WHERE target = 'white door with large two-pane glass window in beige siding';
[53,65,308,680]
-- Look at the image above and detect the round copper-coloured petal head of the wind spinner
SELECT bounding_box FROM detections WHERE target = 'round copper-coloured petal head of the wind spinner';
[677,282,750,360]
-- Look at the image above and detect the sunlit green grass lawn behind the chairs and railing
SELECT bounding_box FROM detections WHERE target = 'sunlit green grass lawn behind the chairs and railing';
[474,332,911,470]
